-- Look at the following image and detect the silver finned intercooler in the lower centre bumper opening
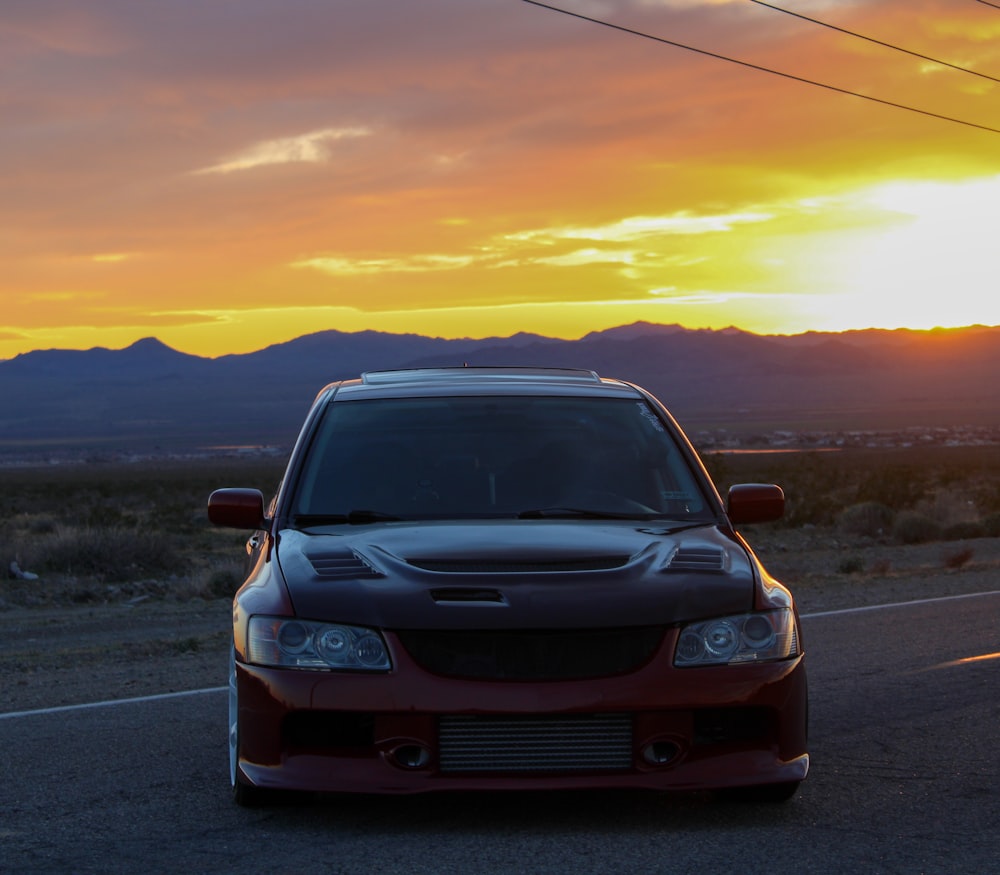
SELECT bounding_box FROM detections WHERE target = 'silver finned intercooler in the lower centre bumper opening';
[438,714,632,774]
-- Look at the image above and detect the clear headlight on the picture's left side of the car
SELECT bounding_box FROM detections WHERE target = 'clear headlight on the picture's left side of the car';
[247,617,392,671]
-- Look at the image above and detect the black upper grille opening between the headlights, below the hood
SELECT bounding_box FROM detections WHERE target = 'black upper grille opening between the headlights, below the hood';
[397,626,664,681]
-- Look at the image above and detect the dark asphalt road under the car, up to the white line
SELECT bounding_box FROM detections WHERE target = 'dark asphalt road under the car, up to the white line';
[0,594,1000,875]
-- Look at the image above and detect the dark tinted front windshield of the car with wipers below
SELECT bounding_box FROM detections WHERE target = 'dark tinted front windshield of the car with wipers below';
[292,396,711,525]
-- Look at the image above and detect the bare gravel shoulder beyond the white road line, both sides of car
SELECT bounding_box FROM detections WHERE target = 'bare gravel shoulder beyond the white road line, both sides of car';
[0,529,1000,713]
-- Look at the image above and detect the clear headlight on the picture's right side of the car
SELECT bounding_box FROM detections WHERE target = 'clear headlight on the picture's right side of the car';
[674,608,799,668]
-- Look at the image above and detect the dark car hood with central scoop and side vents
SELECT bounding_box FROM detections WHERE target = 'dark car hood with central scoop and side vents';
[275,520,755,629]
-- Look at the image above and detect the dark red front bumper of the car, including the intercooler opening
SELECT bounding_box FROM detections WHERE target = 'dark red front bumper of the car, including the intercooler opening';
[236,633,809,793]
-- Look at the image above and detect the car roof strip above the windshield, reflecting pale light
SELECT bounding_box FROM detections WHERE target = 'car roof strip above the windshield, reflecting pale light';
[327,366,639,398]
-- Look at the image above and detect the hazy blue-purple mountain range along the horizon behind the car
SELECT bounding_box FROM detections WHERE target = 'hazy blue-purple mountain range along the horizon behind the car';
[0,323,1000,452]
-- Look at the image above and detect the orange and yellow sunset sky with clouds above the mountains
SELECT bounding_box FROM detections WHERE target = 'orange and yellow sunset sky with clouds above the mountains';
[0,0,1000,359]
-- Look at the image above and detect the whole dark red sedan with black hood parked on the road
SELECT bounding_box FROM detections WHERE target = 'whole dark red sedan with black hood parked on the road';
[208,368,809,804]
